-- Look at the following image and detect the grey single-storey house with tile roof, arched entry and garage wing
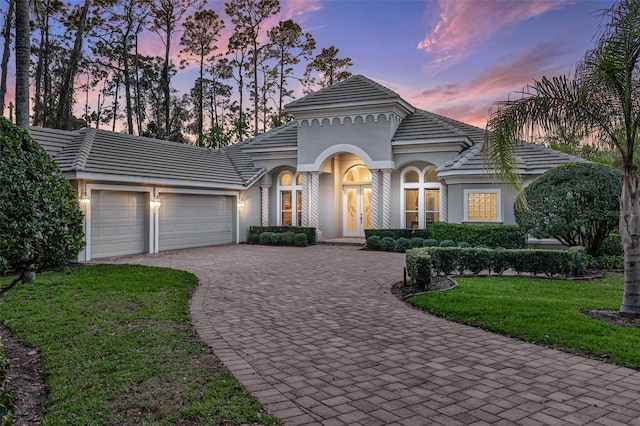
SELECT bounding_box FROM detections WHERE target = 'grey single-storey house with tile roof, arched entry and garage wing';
[30,75,584,260]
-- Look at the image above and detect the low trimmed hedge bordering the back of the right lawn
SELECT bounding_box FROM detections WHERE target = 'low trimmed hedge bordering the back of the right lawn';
[407,247,588,280]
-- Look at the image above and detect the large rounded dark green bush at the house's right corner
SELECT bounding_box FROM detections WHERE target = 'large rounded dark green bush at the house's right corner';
[515,163,622,256]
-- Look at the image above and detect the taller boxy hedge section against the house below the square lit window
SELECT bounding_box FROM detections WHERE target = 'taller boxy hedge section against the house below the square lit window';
[427,222,527,248]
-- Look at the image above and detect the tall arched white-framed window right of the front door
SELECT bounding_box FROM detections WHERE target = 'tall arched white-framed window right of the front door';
[401,166,441,228]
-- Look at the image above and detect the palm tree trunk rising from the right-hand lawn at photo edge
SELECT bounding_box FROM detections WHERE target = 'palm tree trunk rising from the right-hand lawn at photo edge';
[620,163,640,316]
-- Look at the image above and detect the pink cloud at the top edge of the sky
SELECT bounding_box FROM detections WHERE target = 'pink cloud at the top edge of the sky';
[418,0,568,63]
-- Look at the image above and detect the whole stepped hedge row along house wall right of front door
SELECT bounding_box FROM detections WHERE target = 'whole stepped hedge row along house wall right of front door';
[364,222,527,249]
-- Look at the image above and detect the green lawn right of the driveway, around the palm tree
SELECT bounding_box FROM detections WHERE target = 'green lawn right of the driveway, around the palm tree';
[409,273,640,369]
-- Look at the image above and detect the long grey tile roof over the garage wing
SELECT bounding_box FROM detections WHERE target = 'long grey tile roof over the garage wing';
[30,128,259,186]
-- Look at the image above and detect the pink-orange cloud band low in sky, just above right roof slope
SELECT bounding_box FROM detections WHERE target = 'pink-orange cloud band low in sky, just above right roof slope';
[408,44,571,127]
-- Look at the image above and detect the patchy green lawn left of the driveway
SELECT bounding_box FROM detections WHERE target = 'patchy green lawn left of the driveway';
[0,265,279,425]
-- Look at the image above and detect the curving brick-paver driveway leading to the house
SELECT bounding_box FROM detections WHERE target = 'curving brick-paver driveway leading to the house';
[111,245,640,426]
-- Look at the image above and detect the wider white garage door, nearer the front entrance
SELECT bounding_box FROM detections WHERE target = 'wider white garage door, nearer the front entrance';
[158,194,234,250]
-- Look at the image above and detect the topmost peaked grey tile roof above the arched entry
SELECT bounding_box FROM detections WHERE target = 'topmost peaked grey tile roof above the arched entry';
[286,75,402,111]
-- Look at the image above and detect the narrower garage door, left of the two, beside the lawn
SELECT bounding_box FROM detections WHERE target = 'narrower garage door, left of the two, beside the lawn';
[91,191,147,258]
